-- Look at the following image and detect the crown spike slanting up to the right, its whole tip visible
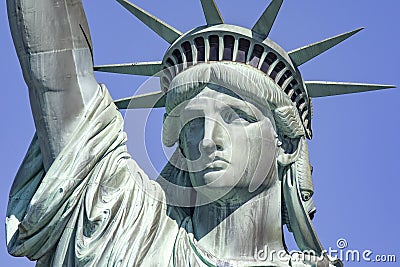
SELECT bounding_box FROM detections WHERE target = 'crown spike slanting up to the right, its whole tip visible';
[289,28,364,66]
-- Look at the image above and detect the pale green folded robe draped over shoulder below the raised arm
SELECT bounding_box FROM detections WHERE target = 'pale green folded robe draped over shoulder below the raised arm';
[6,86,178,266]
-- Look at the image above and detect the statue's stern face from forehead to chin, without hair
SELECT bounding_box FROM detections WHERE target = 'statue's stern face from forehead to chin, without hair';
[180,85,277,203]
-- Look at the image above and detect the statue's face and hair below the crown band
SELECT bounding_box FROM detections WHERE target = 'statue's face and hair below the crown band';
[163,62,304,205]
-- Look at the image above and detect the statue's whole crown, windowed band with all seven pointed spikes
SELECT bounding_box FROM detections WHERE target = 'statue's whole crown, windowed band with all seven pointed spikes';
[94,0,394,139]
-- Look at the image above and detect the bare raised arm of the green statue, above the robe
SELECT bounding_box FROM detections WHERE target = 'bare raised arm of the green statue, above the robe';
[7,0,98,170]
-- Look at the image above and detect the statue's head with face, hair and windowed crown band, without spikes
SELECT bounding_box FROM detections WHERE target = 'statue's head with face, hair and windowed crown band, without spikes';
[161,25,313,209]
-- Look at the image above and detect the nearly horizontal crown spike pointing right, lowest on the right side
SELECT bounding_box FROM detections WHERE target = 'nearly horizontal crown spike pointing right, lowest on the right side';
[304,81,396,97]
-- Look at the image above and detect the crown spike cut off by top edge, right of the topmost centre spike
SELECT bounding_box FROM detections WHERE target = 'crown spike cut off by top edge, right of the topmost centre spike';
[251,0,283,39]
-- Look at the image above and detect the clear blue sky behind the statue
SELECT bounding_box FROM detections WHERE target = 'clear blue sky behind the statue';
[0,0,400,266]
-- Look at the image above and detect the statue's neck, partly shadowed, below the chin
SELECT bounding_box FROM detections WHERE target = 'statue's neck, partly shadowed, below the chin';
[193,182,284,261]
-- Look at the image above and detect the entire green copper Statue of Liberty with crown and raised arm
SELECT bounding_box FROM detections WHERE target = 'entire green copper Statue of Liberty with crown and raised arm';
[6,0,390,266]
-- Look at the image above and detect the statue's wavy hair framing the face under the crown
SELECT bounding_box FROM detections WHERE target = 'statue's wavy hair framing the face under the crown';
[158,62,314,225]
